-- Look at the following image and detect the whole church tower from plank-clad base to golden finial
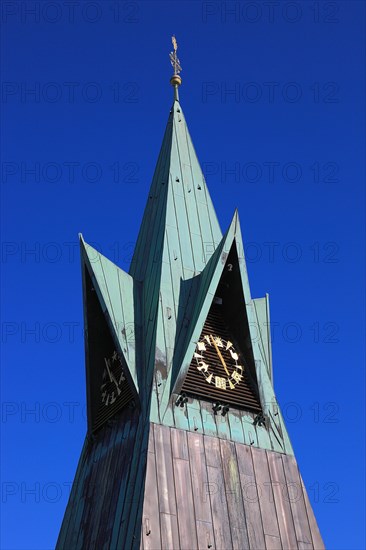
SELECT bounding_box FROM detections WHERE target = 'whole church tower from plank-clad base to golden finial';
[57,37,324,550]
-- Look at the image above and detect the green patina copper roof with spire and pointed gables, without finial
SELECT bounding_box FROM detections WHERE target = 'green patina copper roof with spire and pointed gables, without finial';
[82,96,292,453]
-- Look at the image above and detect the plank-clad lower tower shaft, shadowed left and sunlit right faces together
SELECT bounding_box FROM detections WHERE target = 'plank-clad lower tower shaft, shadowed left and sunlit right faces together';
[57,418,324,550]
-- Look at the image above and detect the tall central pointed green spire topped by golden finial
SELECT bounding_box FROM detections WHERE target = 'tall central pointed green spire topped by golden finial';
[129,38,222,410]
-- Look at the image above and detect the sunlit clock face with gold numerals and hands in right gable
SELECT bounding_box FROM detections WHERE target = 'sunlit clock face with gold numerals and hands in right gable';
[194,334,244,391]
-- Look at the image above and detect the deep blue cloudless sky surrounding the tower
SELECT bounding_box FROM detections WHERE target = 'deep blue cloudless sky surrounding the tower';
[1,0,365,550]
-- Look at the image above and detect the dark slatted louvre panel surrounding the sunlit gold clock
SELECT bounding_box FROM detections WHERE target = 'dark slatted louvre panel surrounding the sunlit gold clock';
[182,304,261,412]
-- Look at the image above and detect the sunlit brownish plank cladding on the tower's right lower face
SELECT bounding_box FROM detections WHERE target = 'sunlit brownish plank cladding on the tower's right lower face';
[140,424,324,550]
